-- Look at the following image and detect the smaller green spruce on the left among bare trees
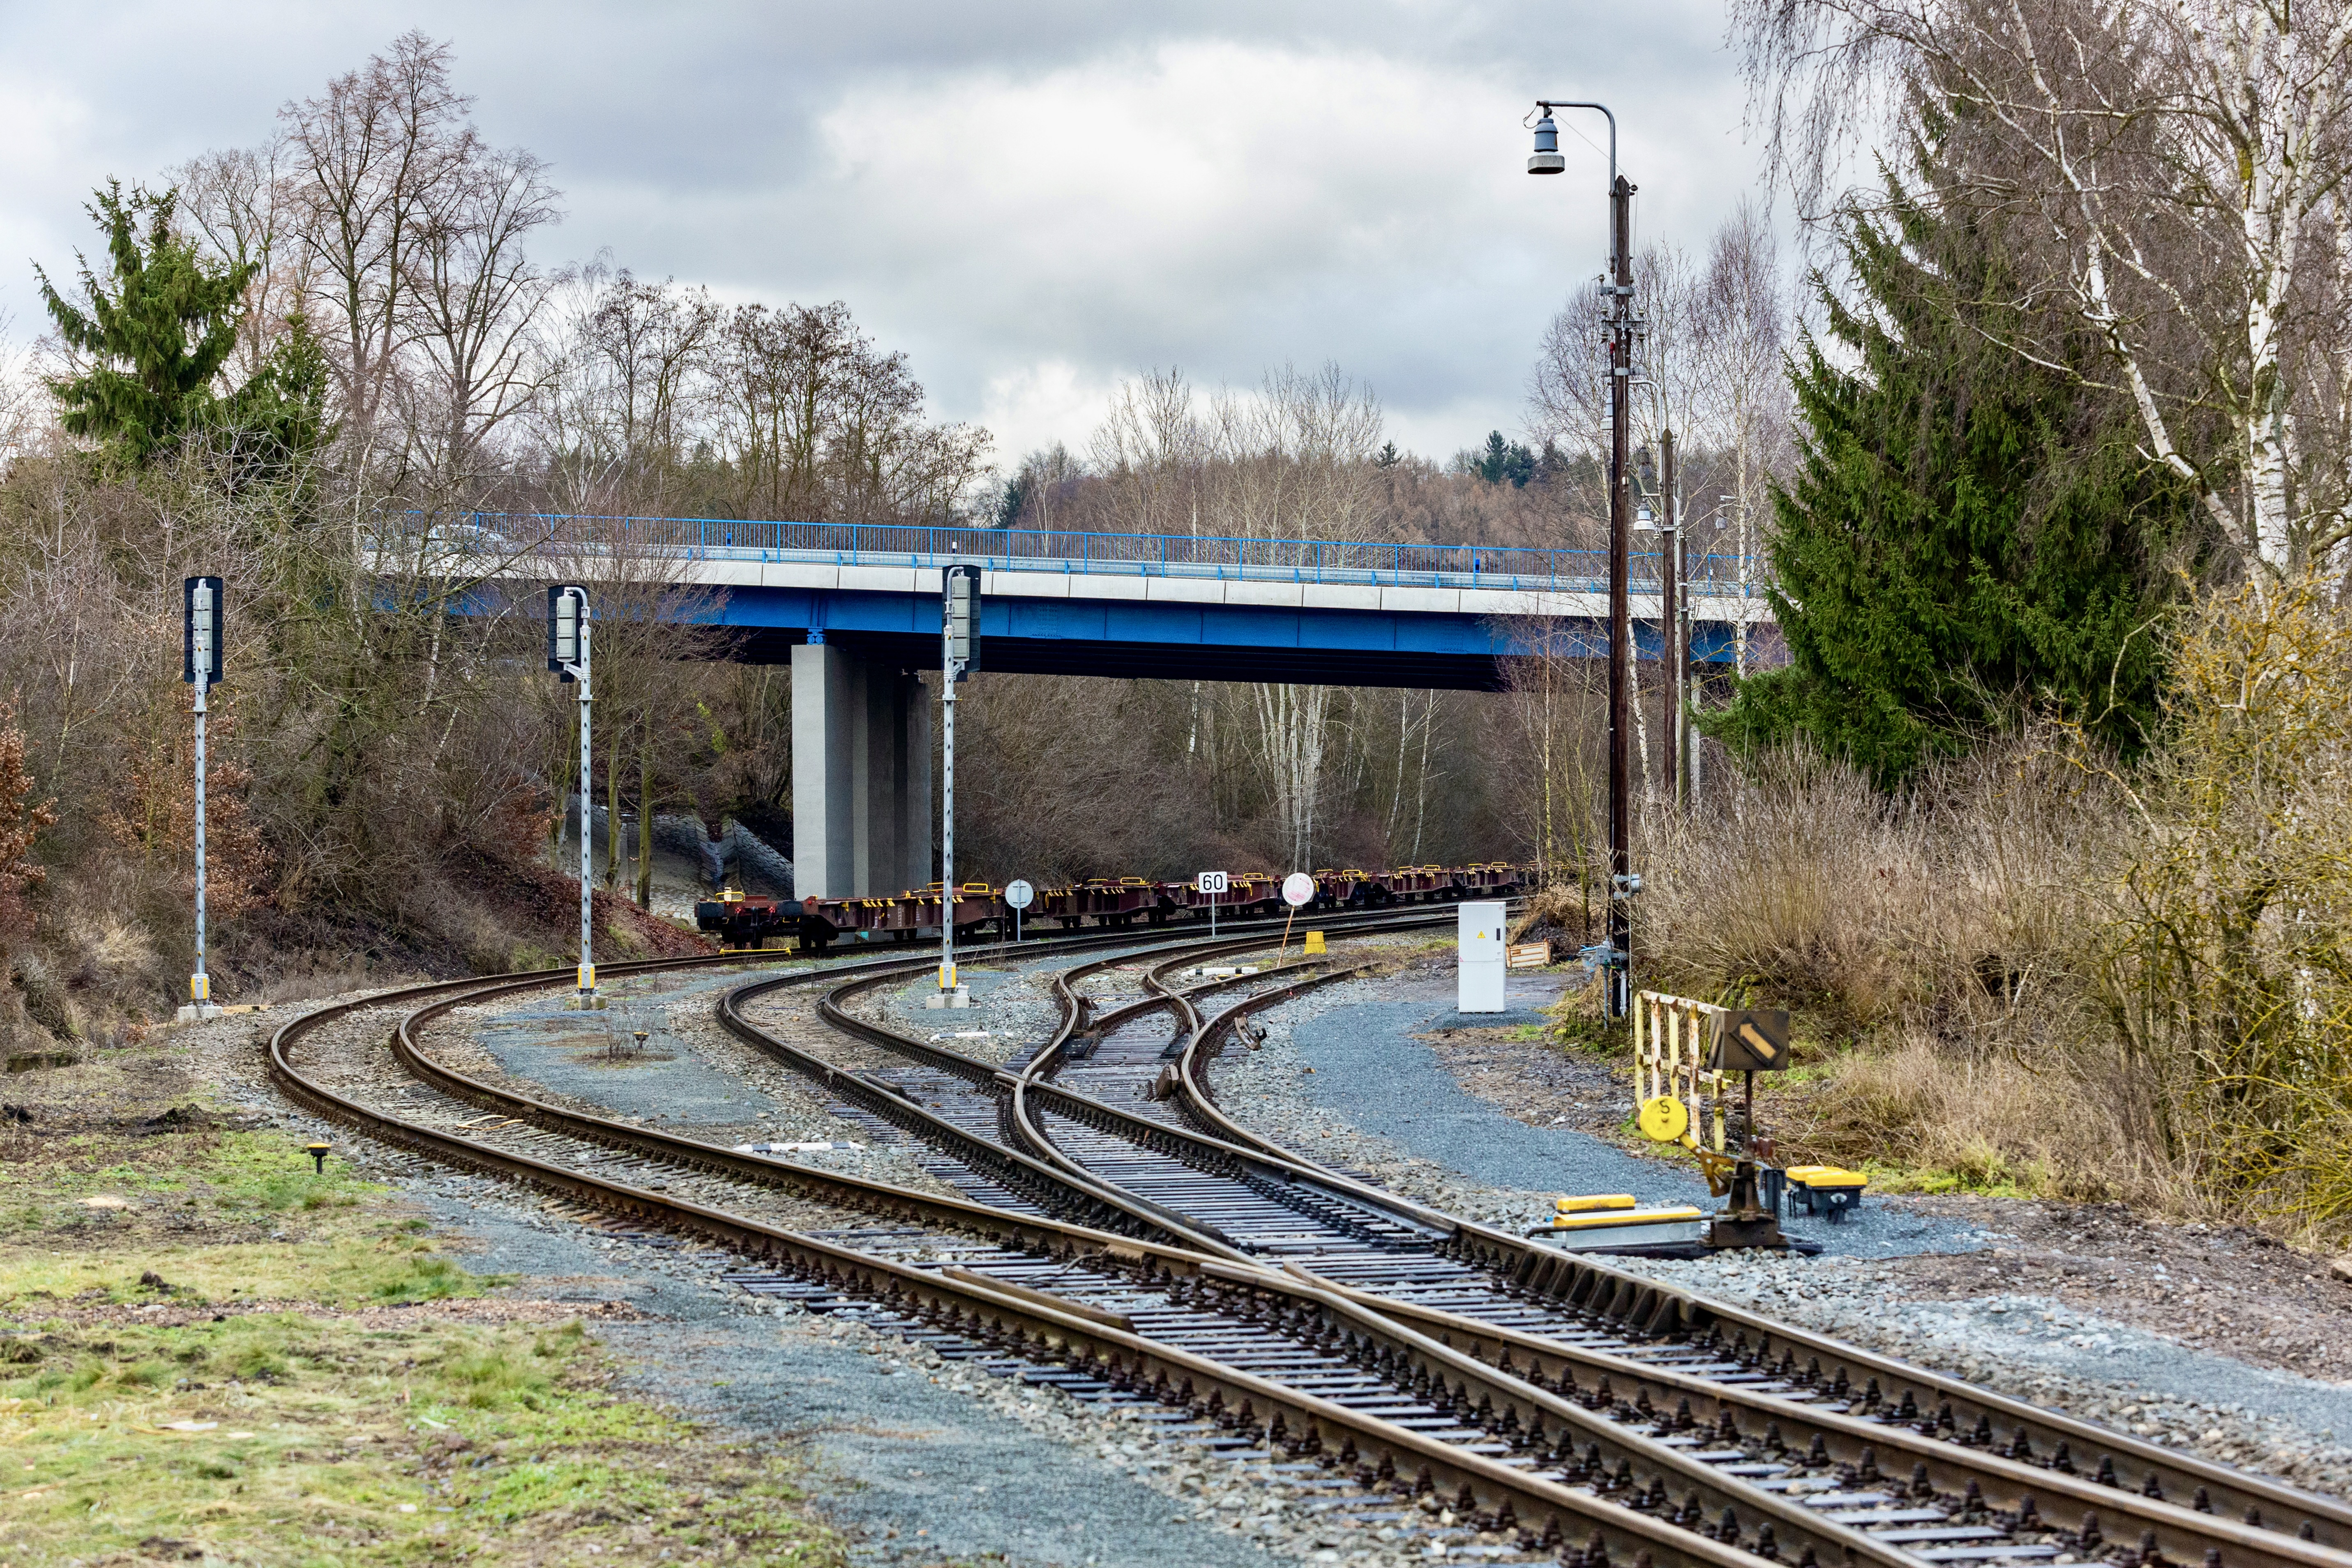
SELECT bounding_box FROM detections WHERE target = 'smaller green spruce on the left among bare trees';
[33,181,254,466]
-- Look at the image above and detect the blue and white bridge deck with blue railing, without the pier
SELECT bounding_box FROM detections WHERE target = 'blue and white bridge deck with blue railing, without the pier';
[435,512,1776,691]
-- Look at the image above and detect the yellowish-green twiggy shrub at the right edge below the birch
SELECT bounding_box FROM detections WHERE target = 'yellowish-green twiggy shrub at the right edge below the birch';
[2093,578,2352,1234]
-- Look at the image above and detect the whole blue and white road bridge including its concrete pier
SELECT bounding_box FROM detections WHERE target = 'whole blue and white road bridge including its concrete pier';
[414,512,1778,898]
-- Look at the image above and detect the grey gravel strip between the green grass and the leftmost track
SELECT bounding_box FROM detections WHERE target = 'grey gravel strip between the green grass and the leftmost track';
[404,1178,1298,1568]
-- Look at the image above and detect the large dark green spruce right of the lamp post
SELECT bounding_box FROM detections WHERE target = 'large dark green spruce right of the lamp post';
[1703,179,2197,788]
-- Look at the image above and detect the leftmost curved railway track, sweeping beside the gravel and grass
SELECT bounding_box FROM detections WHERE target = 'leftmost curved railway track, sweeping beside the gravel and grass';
[270,940,1872,1568]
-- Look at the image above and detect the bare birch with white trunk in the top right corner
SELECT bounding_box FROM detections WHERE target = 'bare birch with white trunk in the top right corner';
[1734,0,2352,581]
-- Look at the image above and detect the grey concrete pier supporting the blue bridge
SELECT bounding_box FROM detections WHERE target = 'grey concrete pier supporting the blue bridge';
[793,642,934,898]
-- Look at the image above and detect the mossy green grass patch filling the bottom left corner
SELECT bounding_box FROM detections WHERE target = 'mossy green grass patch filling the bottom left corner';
[0,1314,839,1568]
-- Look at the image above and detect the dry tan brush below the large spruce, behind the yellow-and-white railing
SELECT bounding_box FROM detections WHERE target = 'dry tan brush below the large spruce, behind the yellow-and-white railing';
[1637,736,2166,1197]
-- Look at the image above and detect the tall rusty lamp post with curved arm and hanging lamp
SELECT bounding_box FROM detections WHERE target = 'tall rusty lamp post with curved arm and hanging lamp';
[1526,99,1642,1018]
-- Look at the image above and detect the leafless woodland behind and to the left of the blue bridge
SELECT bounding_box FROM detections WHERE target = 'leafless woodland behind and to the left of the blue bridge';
[0,33,1785,1032]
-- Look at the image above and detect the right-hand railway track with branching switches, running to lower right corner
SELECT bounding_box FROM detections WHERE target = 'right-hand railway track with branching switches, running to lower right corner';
[724,921,2347,1563]
